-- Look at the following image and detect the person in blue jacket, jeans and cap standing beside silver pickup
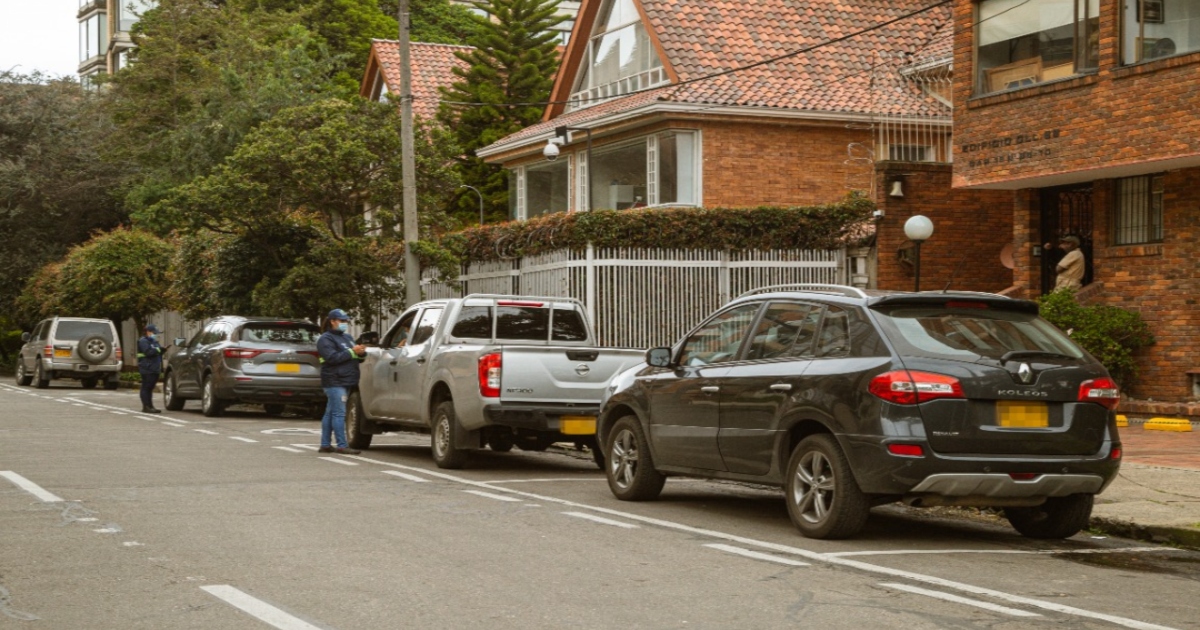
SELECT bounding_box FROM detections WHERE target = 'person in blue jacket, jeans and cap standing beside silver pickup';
[317,308,367,455]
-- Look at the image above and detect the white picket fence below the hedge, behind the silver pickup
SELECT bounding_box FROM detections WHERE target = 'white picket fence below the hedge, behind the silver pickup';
[422,246,868,348]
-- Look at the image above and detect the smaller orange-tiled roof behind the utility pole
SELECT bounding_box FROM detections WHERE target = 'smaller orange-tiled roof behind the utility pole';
[360,40,473,120]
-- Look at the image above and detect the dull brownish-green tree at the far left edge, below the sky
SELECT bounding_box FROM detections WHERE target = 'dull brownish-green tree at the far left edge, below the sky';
[0,72,128,324]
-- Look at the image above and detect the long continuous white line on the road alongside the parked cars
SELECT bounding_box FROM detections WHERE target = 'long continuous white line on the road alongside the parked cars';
[338,456,1175,630]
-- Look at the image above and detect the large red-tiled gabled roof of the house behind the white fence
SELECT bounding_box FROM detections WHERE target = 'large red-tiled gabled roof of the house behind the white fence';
[481,0,953,154]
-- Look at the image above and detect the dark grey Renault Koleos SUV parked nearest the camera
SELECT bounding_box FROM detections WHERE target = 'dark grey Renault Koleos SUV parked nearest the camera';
[598,284,1121,539]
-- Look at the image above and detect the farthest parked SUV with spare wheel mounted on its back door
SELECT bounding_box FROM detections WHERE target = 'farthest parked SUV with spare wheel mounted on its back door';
[17,317,121,389]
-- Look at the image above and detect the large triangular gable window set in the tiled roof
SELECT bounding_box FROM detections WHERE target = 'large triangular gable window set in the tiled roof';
[568,0,668,110]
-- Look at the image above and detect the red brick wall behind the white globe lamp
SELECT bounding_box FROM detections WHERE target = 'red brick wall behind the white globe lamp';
[876,162,1014,293]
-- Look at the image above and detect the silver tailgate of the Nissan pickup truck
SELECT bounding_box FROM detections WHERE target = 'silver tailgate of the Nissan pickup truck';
[500,346,646,404]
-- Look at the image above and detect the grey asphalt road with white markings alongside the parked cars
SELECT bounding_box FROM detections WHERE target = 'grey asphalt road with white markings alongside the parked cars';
[0,384,1200,630]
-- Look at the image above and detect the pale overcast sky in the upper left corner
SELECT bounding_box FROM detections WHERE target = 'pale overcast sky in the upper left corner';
[0,0,79,77]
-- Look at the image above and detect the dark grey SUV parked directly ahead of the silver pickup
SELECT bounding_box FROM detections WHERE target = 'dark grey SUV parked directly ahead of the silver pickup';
[162,316,325,416]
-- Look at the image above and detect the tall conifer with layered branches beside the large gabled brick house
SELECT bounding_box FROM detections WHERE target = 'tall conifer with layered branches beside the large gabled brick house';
[438,0,568,223]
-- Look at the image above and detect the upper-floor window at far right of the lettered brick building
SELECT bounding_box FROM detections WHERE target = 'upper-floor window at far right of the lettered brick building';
[1121,0,1200,64]
